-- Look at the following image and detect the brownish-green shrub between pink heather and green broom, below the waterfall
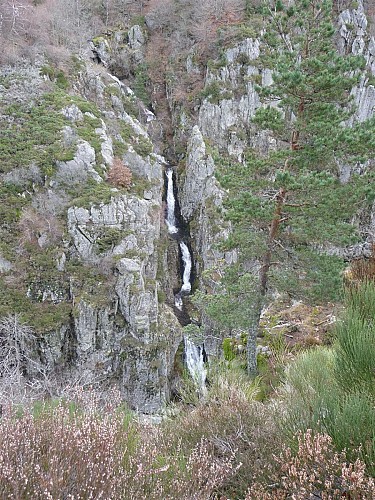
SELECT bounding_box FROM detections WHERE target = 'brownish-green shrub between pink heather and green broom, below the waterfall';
[160,364,281,498]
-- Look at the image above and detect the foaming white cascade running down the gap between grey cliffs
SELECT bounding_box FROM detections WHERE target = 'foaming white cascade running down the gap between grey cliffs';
[165,168,207,396]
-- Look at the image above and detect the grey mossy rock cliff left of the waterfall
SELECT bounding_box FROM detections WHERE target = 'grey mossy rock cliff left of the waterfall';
[1,57,182,413]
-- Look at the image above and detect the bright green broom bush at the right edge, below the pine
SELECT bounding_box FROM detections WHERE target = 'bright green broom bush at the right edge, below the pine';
[282,284,375,472]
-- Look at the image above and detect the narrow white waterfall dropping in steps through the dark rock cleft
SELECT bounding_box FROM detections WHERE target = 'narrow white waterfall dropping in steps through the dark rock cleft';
[165,167,207,395]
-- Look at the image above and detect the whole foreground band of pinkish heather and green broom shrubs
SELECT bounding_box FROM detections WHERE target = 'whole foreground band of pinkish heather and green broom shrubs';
[0,282,375,500]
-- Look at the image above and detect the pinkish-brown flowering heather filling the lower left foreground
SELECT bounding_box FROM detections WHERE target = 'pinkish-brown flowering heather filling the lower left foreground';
[0,391,233,500]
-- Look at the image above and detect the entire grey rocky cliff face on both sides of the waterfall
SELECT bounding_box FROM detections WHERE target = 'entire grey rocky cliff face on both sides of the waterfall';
[0,0,375,413]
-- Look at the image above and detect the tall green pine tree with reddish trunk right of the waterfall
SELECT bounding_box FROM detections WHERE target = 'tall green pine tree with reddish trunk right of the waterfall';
[203,0,375,374]
